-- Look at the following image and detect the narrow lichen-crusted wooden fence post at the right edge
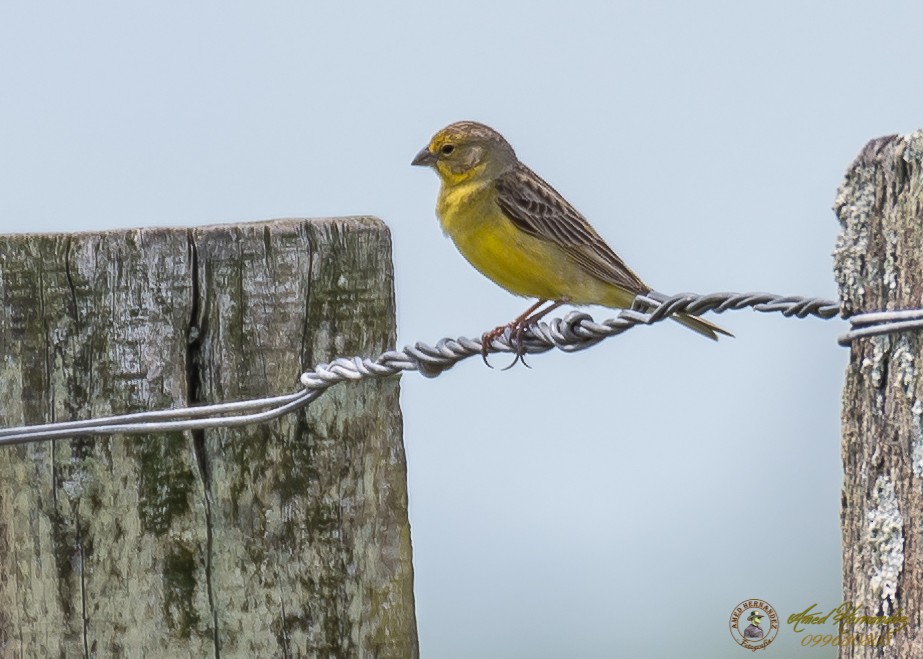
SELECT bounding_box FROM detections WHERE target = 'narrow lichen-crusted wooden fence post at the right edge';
[835,131,923,659]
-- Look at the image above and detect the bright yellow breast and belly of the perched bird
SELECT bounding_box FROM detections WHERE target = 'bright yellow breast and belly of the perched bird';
[436,182,606,304]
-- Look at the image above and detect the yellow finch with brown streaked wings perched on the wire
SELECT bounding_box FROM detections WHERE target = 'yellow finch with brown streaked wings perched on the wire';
[412,121,731,363]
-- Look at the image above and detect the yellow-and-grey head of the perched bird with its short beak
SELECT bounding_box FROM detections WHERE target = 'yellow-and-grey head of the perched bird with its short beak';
[411,121,516,184]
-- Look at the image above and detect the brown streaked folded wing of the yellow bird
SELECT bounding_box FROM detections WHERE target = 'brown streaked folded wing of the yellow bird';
[496,164,650,293]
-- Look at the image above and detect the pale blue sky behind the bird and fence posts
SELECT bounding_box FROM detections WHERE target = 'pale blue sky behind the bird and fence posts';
[0,1,923,659]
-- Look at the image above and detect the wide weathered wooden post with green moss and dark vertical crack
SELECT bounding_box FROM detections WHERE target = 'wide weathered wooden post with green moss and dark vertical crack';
[0,218,417,659]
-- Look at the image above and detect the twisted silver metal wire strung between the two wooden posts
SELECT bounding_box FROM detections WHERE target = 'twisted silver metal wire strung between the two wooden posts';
[0,292,904,446]
